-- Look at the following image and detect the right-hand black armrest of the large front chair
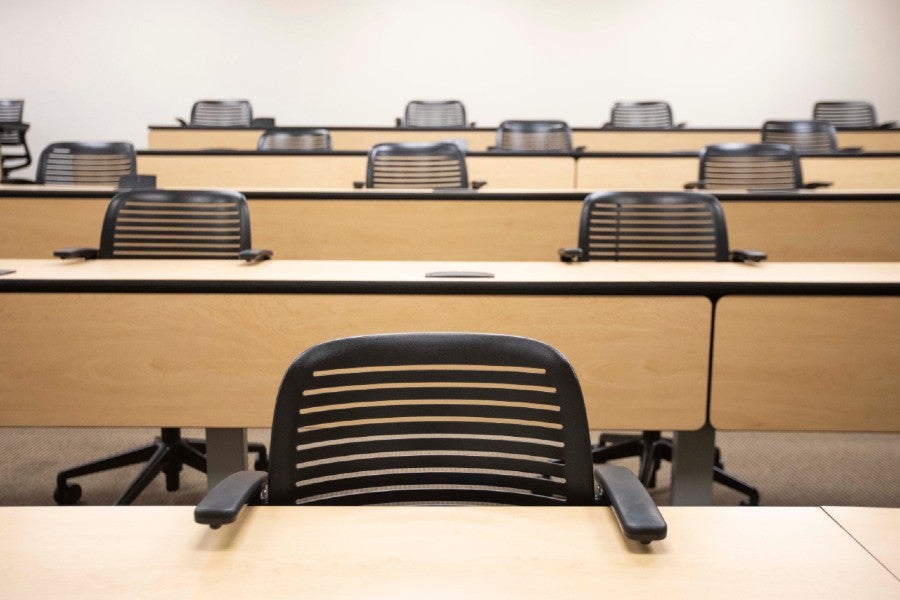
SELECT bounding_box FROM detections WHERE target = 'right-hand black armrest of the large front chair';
[594,465,667,544]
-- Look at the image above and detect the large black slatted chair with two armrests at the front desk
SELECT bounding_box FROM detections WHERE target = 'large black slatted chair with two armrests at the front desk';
[194,333,666,543]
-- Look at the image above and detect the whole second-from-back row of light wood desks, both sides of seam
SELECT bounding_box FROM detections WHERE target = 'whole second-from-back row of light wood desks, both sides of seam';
[137,151,900,190]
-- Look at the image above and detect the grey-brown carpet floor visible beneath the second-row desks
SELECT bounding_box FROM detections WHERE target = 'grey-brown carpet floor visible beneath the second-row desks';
[0,428,900,507]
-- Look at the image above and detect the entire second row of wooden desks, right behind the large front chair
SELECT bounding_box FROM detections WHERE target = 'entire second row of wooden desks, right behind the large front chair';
[0,259,900,504]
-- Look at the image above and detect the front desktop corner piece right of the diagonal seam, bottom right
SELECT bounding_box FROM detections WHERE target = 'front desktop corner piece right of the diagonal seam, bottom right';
[823,506,900,579]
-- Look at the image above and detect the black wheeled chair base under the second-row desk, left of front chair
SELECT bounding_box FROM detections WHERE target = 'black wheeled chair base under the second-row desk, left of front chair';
[53,427,268,506]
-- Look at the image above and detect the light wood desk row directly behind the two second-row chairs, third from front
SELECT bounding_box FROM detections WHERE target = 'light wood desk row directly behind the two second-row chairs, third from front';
[0,185,900,262]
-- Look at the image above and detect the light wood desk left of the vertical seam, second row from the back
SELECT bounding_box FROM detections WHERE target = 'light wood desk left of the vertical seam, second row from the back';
[137,151,572,190]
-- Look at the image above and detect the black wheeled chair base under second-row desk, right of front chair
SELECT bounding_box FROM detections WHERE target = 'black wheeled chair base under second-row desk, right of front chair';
[591,431,759,506]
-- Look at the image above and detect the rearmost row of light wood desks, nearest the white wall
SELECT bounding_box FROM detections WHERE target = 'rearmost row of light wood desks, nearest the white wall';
[147,125,900,152]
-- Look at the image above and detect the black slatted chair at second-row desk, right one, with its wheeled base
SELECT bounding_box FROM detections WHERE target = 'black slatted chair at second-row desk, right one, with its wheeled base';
[560,192,765,505]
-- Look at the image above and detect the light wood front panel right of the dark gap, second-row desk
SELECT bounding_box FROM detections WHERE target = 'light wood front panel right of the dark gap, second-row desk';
[710,296,900,431]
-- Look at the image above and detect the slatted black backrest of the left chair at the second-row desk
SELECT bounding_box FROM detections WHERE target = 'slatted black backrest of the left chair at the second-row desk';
[100,190,251,259]
